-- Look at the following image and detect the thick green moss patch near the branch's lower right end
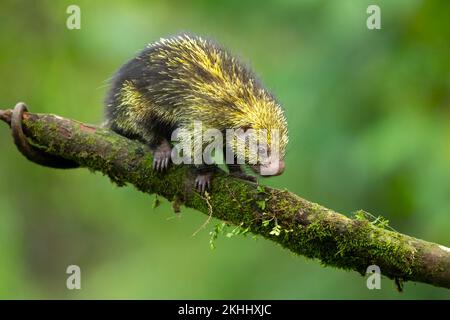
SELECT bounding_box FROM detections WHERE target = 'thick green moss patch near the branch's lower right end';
[268,206,415,279]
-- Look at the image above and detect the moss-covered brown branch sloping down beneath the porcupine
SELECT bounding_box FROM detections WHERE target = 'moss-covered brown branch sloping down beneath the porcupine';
[0,105,450,288]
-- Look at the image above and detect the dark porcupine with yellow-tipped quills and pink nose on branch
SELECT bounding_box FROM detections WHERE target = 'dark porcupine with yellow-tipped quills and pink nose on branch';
[106,34,288,191]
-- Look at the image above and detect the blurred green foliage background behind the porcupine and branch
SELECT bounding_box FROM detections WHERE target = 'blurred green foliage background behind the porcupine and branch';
[0,0,450,299]
